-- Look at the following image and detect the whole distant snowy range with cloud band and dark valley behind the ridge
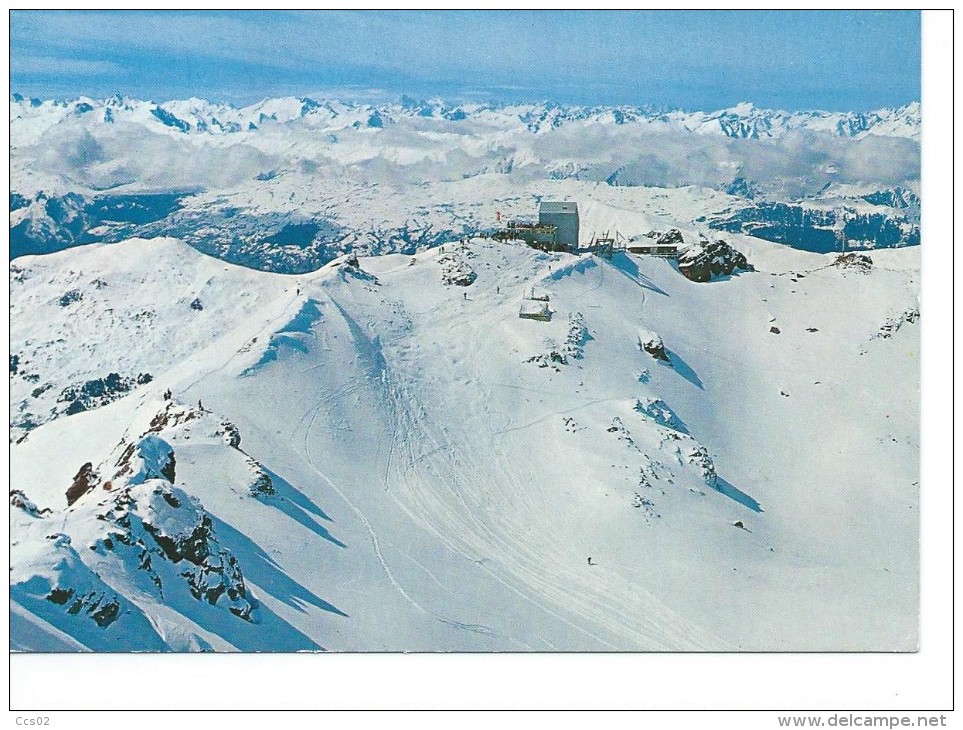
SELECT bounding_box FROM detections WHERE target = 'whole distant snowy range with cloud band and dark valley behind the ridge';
[10,94,920,273]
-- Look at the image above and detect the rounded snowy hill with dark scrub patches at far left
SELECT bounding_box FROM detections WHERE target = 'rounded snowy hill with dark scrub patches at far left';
[10,239,294,439]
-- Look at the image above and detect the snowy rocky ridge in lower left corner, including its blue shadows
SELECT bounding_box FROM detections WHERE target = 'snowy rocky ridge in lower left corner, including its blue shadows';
[11,401,334,651]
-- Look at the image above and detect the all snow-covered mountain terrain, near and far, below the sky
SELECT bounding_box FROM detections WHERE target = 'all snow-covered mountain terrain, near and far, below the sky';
[10,88,922,651]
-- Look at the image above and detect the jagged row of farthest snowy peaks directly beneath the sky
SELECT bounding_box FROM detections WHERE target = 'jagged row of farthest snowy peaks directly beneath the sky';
[11,94,920,139]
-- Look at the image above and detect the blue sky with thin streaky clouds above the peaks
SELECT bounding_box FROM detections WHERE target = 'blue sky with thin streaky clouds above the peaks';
[10,10,920,111]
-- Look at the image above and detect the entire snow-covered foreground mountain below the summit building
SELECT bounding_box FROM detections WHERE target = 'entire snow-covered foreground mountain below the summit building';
[11,233,919,651]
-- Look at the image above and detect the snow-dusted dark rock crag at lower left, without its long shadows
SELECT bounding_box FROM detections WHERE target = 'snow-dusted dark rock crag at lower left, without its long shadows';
[10,400,275,650]
